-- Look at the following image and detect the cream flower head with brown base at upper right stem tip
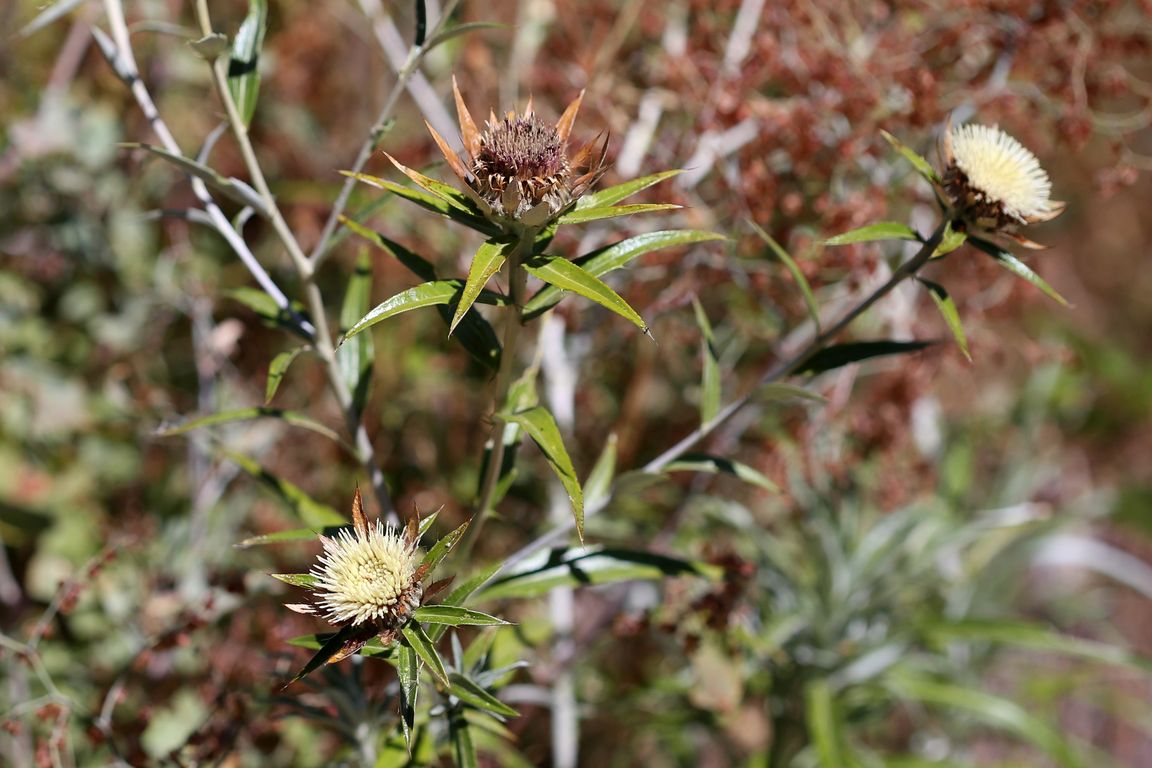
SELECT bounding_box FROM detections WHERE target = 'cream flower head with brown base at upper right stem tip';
[941,126,1064,245]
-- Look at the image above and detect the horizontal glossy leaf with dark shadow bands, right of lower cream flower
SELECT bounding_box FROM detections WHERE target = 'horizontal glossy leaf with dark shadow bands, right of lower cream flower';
[480,547,722,600]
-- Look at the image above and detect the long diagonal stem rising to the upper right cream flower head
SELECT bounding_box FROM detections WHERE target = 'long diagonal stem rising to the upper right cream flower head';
[492,222,947,578]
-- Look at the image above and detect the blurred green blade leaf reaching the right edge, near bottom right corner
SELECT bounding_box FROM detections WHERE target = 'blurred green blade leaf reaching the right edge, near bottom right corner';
[924,619,1152,674]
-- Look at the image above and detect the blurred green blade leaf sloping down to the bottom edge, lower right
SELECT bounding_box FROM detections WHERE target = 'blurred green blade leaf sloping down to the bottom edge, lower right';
[886,672,1081,768]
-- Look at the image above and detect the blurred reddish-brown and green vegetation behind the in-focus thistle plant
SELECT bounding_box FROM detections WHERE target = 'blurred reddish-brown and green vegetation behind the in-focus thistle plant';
[0,0,1152,766]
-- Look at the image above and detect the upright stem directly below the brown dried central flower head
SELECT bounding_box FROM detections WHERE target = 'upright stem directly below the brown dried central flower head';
[460,228,537,557]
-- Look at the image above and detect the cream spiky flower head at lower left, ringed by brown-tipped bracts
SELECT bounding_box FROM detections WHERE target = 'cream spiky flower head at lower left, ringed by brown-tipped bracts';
[311,520,422,624]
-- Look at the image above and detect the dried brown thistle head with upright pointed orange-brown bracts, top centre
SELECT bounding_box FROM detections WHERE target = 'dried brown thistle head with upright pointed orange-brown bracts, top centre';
[429,78,608,227]
